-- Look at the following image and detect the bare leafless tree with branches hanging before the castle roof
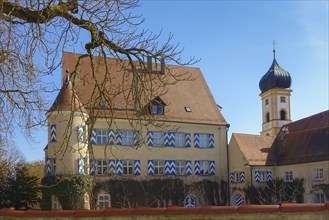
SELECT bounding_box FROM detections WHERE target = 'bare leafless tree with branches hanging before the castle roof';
[0,0,196,146]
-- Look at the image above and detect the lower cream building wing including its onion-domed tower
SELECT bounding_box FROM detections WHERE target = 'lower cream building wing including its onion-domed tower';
[228,50,329,206]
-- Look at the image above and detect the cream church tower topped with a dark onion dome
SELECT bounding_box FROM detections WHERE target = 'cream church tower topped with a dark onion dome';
[259,48,292,136]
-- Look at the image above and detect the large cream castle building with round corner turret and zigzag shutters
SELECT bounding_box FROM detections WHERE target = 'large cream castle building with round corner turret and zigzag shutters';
[45,52,228,209]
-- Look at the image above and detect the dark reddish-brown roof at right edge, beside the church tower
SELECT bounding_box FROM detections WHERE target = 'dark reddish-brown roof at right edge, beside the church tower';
[272,110,329,165]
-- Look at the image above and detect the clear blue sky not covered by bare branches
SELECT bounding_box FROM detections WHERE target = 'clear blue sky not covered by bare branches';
[18,0,329,161]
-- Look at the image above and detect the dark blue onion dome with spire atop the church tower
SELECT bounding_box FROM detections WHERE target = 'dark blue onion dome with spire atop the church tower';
[259,55,291,93]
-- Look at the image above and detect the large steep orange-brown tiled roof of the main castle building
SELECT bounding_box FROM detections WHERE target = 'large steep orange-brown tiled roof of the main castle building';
[55,52,227,125]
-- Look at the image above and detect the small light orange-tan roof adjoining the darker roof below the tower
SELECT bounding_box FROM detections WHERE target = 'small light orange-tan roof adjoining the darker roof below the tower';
[232,133,274,166]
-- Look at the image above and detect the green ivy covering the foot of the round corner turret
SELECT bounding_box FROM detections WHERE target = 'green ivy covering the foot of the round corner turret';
[41,175,94,210]
